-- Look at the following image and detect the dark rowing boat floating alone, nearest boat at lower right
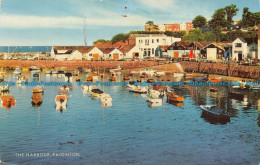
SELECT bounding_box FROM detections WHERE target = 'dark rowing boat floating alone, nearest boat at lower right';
[200,105,230,121]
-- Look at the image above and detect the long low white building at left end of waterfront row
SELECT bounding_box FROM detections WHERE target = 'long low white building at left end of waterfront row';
[51,46,82,60]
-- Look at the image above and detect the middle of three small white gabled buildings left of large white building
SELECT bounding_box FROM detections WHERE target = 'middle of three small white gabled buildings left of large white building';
[100,48,123,60]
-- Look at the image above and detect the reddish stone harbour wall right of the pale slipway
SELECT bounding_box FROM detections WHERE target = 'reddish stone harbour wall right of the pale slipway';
[180,61,260,79]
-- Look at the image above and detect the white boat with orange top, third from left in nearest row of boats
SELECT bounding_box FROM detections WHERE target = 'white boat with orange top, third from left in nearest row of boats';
[55,89,69,111]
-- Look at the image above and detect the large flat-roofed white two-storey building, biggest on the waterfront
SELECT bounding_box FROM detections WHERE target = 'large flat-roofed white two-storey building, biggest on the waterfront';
[132,34,181,58]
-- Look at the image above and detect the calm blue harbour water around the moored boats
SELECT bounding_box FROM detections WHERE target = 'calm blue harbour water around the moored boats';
[0,73,260,165]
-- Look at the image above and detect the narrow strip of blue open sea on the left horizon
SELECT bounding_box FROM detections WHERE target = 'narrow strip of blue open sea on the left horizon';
[0,46,52,53]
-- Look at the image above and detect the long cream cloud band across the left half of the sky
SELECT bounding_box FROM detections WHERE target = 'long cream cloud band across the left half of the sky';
[0,14,148,29]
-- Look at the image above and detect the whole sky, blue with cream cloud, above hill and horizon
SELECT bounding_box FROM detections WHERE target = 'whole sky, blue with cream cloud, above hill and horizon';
[0,0,260,46]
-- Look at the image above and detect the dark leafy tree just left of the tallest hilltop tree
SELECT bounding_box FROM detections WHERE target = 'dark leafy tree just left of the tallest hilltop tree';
[209,8,227,29]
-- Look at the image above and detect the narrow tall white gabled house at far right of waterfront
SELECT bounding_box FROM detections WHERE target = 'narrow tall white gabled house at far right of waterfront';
[232,38,248,61]
